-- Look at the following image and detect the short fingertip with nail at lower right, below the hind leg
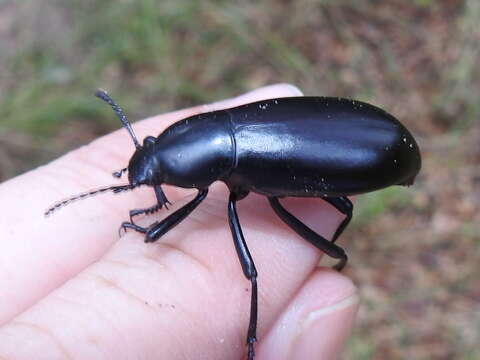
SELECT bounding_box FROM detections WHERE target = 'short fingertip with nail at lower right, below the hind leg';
[257,268,359,360]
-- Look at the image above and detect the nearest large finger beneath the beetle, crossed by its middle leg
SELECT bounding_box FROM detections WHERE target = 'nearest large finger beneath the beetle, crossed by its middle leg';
[0,189,346,360]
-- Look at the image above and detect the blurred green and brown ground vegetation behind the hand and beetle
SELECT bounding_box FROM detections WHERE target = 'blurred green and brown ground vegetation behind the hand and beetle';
[0,0,480,359]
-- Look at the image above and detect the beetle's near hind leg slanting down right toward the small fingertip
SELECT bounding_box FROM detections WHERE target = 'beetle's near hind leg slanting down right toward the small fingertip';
[268,197,348,271]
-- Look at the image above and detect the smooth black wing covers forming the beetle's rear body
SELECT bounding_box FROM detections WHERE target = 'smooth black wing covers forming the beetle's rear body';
[227,97,421,197]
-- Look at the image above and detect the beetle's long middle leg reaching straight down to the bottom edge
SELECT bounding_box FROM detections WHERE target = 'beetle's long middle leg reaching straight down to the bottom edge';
[228,192,258,360]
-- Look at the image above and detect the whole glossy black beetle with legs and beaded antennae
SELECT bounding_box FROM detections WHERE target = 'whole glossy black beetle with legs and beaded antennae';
[45,90,421,360]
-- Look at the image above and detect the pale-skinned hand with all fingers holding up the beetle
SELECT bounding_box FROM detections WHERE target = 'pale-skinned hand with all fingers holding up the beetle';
[0,85,358,360]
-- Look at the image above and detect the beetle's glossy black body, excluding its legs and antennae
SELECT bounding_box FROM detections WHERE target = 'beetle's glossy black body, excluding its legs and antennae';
[138,97,421,197]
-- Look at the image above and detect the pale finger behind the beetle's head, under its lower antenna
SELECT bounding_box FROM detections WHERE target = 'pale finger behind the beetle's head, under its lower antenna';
[0,85,304,323]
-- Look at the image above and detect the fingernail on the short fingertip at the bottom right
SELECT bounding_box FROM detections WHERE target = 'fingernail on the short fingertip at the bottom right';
[288,293,359,360]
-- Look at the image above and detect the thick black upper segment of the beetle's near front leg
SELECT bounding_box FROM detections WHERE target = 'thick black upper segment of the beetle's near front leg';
[145,189,208,242]
